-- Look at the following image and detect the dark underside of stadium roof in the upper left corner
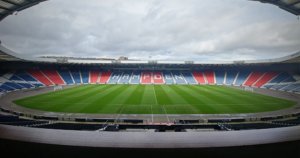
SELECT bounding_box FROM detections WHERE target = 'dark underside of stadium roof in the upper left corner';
[0,0,46,21]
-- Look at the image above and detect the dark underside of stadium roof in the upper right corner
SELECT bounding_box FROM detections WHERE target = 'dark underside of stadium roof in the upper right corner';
[253,0,300,15]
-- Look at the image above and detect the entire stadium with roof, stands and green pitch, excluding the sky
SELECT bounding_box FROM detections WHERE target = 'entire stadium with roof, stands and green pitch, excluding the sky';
[0,0,300,157]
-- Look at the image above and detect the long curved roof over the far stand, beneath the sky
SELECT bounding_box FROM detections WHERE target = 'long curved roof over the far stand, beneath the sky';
[0,43,300,64]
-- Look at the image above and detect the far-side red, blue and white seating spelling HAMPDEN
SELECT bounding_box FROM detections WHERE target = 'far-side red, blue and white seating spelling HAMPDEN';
[0,68,300,93]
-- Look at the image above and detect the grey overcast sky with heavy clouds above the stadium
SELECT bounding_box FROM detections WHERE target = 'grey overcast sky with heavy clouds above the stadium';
[0,0,300,61]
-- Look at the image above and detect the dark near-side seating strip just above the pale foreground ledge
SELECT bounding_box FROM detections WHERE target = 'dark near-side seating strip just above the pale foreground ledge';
[0,111,300,132]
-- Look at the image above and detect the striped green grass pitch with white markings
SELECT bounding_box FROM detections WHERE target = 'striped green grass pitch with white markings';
[14,85,296,114]
